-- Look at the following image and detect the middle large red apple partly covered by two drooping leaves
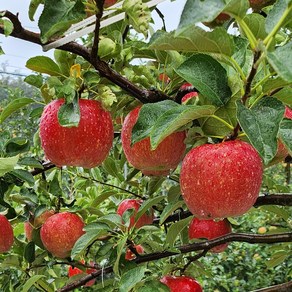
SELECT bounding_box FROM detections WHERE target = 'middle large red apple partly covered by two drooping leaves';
[121,107,186,176]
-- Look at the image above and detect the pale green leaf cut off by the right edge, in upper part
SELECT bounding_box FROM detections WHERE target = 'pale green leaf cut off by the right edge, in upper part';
[267,42,292,82]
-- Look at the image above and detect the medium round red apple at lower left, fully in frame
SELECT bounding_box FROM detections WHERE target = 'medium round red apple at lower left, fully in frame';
[40,212,85,258]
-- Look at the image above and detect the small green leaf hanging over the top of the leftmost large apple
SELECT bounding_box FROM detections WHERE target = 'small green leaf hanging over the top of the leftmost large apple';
[58,97,80,128]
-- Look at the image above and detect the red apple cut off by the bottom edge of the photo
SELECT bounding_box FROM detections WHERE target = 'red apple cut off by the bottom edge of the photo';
[160,276,203,292]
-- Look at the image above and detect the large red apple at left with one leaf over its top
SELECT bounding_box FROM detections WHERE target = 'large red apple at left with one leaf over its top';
[40,99,114,168]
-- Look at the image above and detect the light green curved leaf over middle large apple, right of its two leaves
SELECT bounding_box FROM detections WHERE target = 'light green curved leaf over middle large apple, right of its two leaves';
[150,105,215,150]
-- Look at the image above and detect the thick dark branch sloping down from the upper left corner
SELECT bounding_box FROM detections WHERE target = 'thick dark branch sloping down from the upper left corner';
[0,11,170,103]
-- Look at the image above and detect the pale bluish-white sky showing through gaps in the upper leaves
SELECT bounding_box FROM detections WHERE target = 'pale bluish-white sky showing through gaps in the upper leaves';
[0,0,186,75]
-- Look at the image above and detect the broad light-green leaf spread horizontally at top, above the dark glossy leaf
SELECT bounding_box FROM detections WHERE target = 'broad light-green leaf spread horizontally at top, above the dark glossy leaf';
[149,27,235,57]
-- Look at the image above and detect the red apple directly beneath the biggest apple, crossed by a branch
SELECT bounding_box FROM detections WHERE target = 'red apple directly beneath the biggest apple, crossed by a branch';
[189,218,232,253]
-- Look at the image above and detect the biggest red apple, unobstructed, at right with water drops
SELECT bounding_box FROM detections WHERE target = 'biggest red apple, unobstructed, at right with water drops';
[180,140,263,219]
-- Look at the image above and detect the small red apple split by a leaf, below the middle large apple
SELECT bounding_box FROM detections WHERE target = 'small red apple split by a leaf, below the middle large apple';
[117,199,154,228]
